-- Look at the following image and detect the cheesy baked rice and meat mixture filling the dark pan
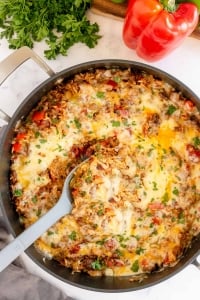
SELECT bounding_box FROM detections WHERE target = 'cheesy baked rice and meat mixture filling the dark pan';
[10,68,200,278]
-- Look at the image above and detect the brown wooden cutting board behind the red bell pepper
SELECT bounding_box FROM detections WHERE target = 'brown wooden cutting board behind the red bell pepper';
[91,0,200,39]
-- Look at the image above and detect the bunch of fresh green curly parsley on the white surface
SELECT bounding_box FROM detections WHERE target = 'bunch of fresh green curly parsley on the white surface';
[0,0,100,59]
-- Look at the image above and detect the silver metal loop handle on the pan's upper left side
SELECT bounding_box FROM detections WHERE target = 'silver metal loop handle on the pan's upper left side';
[0,46,55,122]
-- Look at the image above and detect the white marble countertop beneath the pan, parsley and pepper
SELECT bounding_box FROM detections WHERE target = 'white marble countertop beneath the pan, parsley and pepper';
[0,12,200,300]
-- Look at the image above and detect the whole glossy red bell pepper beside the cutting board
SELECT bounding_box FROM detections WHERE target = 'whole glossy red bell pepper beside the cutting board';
[123,0,199,61]
